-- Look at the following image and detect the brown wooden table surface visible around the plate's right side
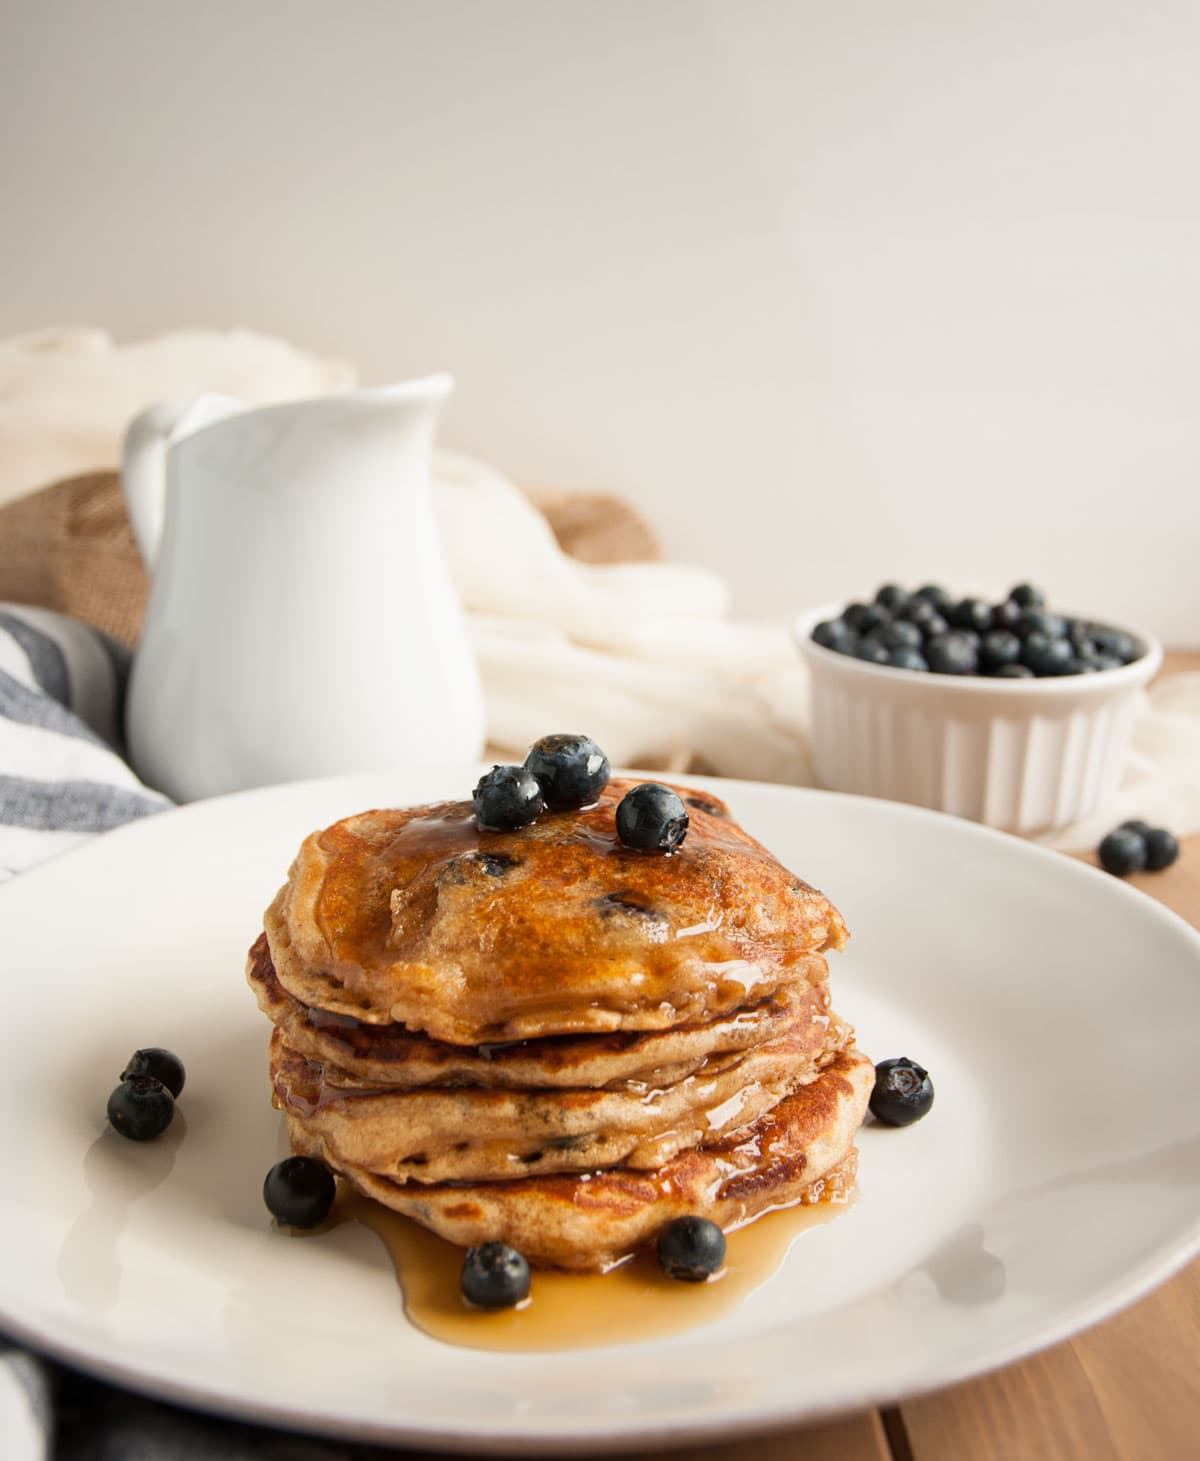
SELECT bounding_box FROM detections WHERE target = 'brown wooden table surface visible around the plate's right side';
[406,652,1200,1461]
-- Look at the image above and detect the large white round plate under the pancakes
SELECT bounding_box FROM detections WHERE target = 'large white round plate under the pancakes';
[0,770,1200,1454]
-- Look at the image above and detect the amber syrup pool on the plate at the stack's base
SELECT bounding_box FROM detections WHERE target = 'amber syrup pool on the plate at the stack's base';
[299,1183,854,1353]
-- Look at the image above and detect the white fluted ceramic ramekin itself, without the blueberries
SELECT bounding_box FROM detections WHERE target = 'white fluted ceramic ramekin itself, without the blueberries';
[795,608,1162,833]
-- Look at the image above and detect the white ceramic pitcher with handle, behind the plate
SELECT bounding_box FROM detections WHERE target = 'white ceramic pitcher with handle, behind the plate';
[123,375,484,801]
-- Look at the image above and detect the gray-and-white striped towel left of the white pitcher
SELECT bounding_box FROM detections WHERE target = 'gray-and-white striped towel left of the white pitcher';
[0,603,170,881]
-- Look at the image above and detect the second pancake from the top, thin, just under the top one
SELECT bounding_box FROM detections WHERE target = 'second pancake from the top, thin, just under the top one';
[246,935,845,1090]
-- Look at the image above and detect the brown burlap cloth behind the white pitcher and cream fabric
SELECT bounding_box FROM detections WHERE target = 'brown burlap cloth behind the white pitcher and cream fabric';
[0,472,659,646]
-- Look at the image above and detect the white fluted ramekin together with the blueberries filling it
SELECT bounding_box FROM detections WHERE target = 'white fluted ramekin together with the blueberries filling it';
[797,583,1162,834]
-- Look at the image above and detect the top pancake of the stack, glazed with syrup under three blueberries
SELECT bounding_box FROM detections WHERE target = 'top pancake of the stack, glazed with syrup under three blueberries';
[265,779,846,1045]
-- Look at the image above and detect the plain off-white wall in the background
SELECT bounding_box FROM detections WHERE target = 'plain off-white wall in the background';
[0,0,1200,643]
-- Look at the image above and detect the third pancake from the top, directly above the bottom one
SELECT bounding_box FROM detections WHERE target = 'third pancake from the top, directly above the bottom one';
[269,1005,836,1182]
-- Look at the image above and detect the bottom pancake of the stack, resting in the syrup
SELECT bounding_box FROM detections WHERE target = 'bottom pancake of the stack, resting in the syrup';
[288,1049,874,1270]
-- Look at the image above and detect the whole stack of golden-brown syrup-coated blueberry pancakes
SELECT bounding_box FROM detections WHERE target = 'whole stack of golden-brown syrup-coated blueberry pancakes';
[248,780,874,1268]
